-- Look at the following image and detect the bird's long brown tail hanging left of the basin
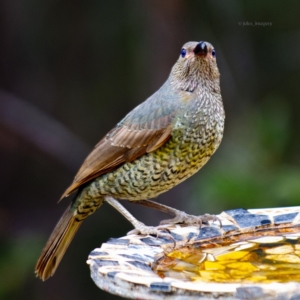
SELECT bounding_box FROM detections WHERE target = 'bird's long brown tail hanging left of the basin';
[35,205,82,281]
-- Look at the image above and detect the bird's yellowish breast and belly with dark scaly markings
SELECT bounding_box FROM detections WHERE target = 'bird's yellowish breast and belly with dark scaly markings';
[92,96,224,200]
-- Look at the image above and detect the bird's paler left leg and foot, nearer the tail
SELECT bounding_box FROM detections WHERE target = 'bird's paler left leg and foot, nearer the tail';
[105,196,176,244]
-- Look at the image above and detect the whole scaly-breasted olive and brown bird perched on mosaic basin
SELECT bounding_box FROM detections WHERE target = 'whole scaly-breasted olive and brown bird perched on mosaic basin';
[35,41,225,281]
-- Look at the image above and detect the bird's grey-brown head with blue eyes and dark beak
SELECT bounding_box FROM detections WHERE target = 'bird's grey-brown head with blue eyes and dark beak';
[171,42,220,92]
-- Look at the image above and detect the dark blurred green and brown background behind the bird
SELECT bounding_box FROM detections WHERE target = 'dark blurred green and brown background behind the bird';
[0,0,300,300]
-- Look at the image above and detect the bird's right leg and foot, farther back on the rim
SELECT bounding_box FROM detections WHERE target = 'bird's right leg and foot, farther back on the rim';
[131,200,222,227]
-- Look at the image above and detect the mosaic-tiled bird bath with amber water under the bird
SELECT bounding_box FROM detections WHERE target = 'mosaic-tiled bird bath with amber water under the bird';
[88,207,300,300]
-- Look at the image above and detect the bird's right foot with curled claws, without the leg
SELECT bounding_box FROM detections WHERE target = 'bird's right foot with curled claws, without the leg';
[160,210,222,228]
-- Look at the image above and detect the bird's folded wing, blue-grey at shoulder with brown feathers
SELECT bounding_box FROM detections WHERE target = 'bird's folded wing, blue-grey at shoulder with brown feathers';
[61,82,180,199]
